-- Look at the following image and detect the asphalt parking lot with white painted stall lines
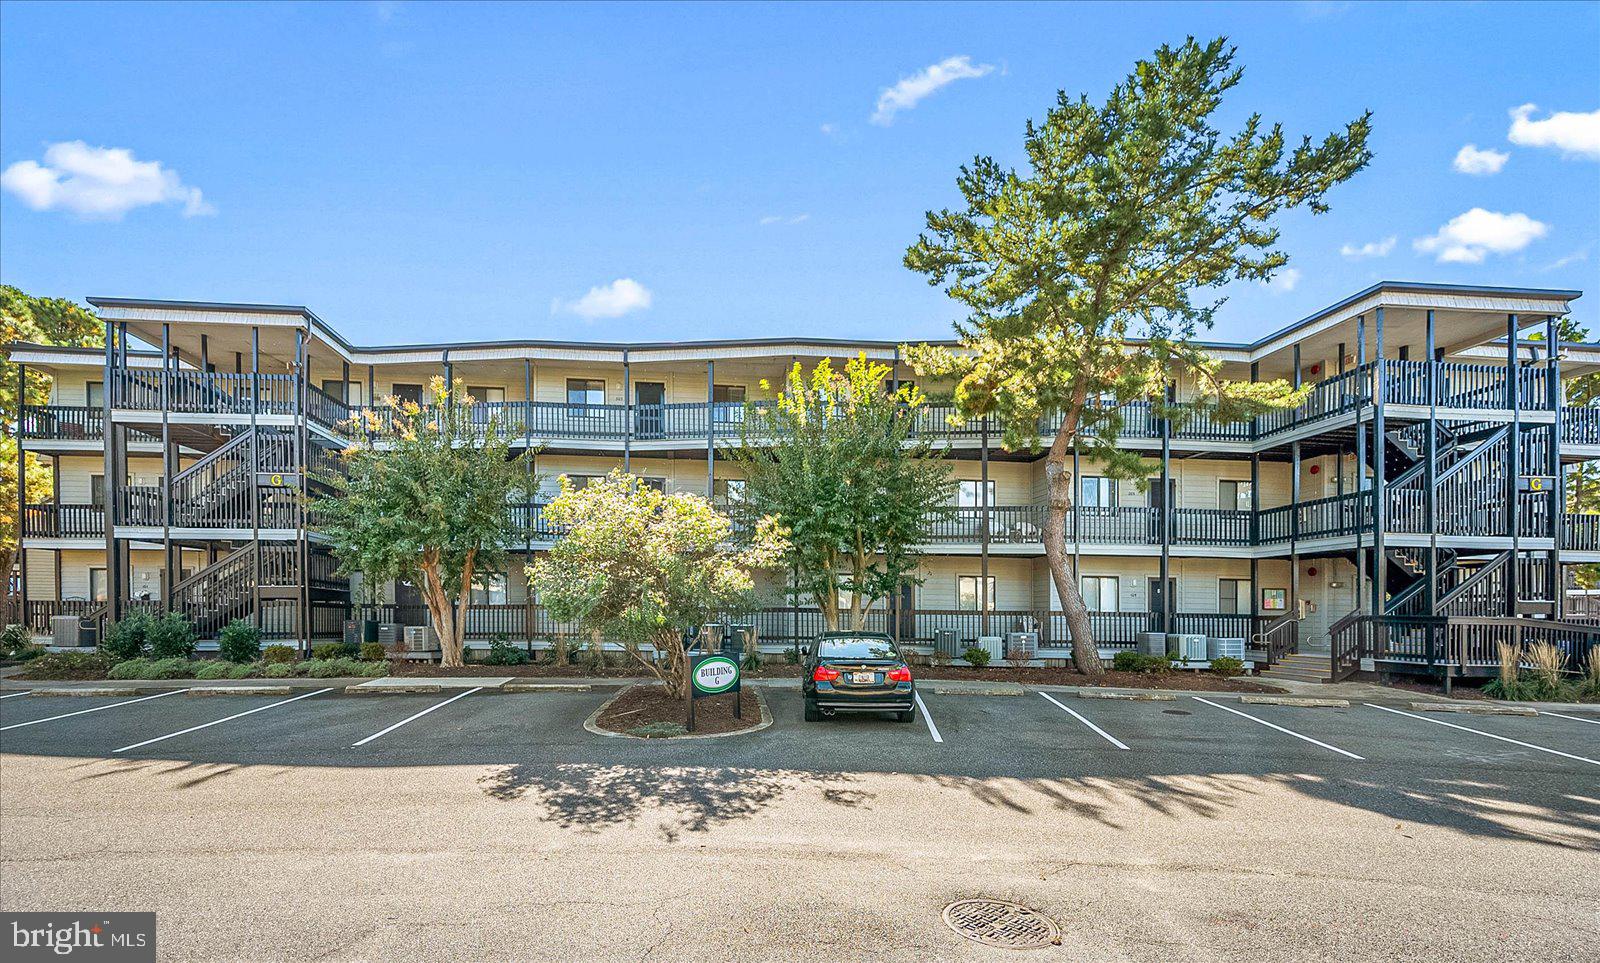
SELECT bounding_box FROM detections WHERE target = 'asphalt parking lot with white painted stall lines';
[0,678,1600,960]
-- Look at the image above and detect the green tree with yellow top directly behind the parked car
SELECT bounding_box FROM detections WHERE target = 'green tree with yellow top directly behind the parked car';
[726,354,955,630]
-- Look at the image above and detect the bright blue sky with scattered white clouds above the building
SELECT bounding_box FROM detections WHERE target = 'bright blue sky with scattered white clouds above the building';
[0,2,1600,342]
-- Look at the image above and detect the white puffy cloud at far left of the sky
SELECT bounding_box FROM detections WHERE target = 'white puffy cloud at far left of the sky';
[0,141,216,221]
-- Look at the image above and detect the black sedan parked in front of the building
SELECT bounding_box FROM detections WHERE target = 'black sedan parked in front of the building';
[800,632,917,721]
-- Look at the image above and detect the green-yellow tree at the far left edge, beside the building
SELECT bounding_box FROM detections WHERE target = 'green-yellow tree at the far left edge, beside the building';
[0,285,106,579]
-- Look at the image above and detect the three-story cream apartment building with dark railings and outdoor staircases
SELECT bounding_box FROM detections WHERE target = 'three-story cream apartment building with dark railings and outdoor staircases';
[6,282,1600,675]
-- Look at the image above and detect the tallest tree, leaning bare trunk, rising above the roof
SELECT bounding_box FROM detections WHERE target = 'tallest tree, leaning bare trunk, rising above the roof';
[906,37,1371,673]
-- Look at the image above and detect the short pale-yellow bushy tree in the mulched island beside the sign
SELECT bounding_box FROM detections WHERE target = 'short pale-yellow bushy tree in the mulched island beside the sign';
[528,470,784,699]
